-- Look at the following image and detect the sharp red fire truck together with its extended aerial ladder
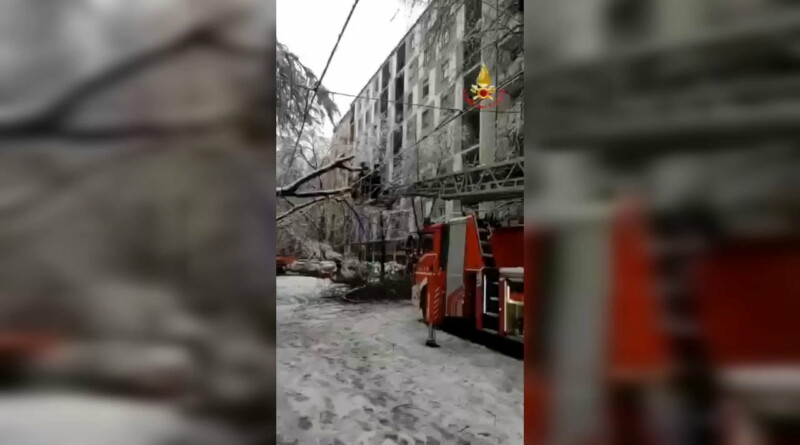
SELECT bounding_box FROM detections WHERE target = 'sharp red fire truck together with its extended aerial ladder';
[376,157,524,347]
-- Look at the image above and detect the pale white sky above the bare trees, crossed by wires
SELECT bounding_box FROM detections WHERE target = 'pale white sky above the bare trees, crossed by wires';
[276,0,423,135]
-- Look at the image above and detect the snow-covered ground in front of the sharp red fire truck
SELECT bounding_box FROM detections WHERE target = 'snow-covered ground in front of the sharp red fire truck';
[277,276,523,445]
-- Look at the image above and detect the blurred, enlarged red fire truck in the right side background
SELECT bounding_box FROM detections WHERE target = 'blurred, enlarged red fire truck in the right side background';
[524,201,800,445]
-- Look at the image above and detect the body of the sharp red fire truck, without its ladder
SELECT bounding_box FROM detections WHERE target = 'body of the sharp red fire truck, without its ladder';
[412,215,524,346]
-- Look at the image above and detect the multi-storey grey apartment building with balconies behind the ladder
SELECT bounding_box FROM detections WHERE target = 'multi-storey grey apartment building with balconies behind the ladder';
[326,0,523,256]
